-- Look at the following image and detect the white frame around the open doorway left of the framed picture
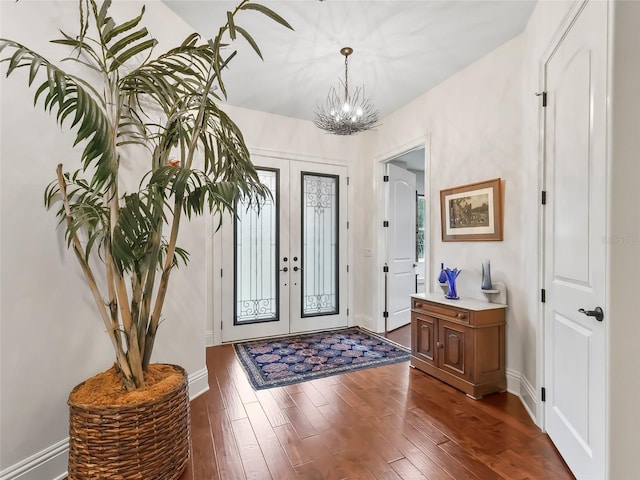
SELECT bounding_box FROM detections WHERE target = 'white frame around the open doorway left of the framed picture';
[372,133,432,333]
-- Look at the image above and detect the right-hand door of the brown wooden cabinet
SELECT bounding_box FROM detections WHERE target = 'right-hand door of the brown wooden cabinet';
[436,320,473,379]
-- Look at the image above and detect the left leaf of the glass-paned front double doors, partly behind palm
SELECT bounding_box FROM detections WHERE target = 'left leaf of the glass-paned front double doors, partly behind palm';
[221,158,290,342]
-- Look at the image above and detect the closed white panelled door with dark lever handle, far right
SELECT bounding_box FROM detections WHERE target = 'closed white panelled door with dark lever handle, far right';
[544,1,607,480]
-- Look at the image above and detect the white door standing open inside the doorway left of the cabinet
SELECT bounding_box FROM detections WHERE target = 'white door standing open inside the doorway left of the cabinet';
[387,163,416,330]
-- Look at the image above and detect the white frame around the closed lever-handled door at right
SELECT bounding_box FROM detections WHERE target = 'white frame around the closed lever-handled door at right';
[535,0,611,472]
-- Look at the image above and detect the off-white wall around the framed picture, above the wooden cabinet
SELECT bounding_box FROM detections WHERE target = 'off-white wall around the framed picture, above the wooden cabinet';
[363,37,526,386]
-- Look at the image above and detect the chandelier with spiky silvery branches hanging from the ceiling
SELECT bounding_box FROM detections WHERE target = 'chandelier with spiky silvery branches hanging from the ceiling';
[313,47,378,135]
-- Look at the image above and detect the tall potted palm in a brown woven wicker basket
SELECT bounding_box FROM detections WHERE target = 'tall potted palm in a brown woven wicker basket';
[0,0,291,480]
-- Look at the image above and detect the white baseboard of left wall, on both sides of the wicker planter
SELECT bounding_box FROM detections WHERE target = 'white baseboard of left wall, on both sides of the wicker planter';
[0,367,209,480]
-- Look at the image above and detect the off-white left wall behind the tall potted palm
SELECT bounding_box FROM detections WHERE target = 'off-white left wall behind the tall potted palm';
[0,1,206,478]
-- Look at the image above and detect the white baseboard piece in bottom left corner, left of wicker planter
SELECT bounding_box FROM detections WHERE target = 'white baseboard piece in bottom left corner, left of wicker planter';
[0,438,69,480]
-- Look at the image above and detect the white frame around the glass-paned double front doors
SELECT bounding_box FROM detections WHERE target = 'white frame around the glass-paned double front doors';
[209,147,354,347]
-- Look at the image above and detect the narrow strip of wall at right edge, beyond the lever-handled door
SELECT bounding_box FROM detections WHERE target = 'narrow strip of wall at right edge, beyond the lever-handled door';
[605,1,640,474]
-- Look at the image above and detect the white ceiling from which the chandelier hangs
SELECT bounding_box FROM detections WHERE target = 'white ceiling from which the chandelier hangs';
[164,0,535,120]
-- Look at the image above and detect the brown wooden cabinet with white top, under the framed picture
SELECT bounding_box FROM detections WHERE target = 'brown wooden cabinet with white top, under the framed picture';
[411,294,507,399]
